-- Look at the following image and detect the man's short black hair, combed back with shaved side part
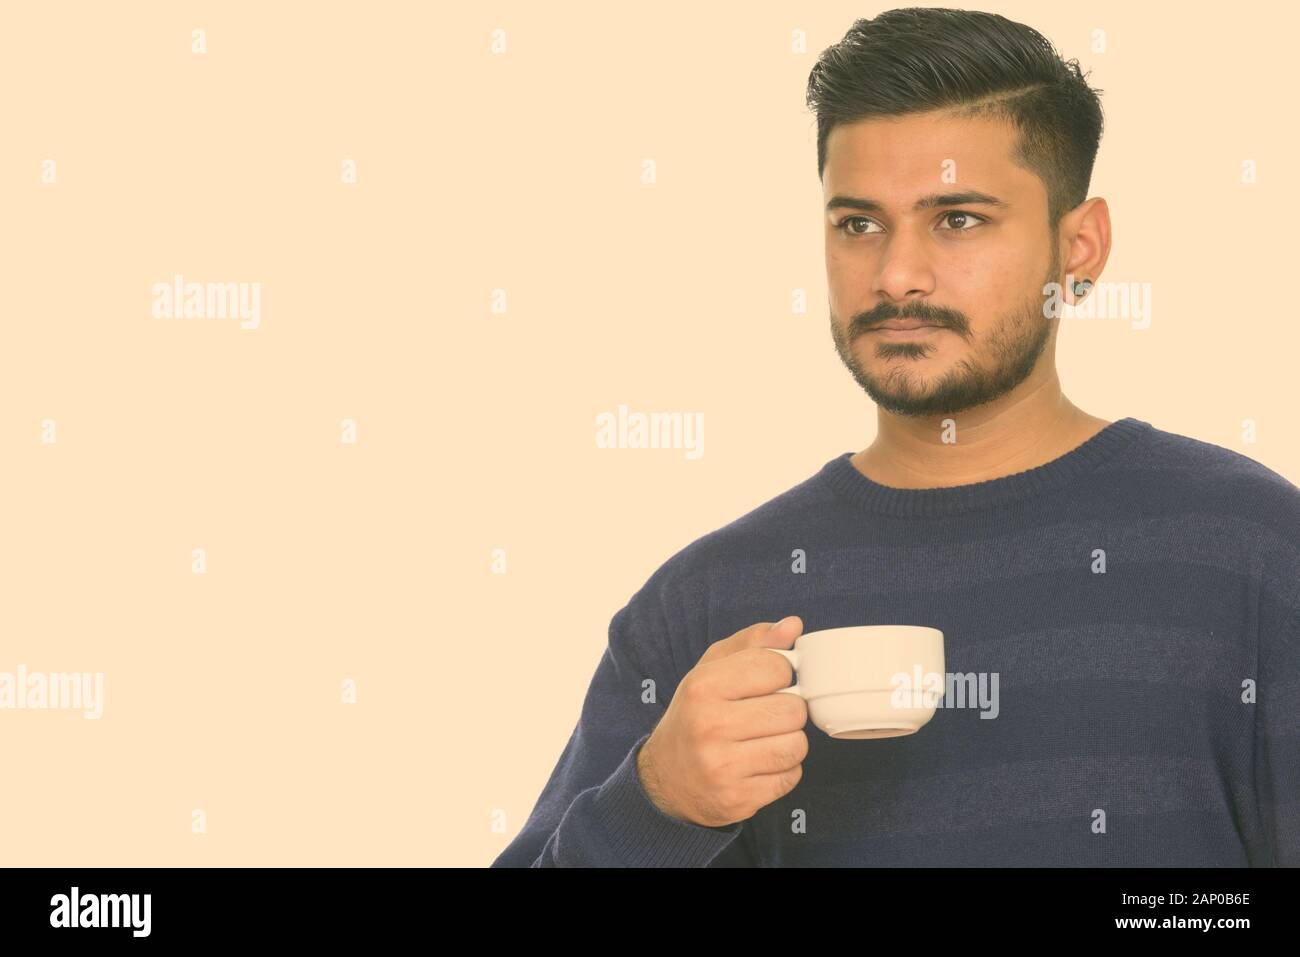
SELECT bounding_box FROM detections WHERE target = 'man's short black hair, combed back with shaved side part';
[807,7,1102,230]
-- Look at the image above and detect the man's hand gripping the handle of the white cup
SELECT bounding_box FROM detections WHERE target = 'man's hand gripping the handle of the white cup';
[637,615,809,827]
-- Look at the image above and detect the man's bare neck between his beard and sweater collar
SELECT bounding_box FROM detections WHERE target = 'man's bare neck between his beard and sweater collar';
[850,395,1110,489]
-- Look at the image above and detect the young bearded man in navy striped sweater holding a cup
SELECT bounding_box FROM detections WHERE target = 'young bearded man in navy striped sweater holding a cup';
[495,9,1300,867]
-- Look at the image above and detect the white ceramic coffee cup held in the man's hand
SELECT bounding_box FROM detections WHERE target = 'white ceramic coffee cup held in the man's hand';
[768,624,945,739]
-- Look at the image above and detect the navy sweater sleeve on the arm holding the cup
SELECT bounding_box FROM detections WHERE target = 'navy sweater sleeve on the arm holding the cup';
[491,588,744,867]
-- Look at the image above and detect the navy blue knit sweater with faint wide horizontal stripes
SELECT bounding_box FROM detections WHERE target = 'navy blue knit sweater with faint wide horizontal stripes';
[493,417,1300,867]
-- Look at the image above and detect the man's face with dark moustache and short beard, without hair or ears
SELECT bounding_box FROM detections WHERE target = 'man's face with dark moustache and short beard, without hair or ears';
[822,113,1061,416]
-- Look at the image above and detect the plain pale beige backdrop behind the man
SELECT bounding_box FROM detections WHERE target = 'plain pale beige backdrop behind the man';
[0,1,1300,866]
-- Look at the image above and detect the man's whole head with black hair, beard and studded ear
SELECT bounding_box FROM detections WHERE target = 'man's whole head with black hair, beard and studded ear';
[809,8,1110,416]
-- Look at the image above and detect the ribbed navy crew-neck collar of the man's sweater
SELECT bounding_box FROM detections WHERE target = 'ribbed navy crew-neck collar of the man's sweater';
[820,416,1154,516]
